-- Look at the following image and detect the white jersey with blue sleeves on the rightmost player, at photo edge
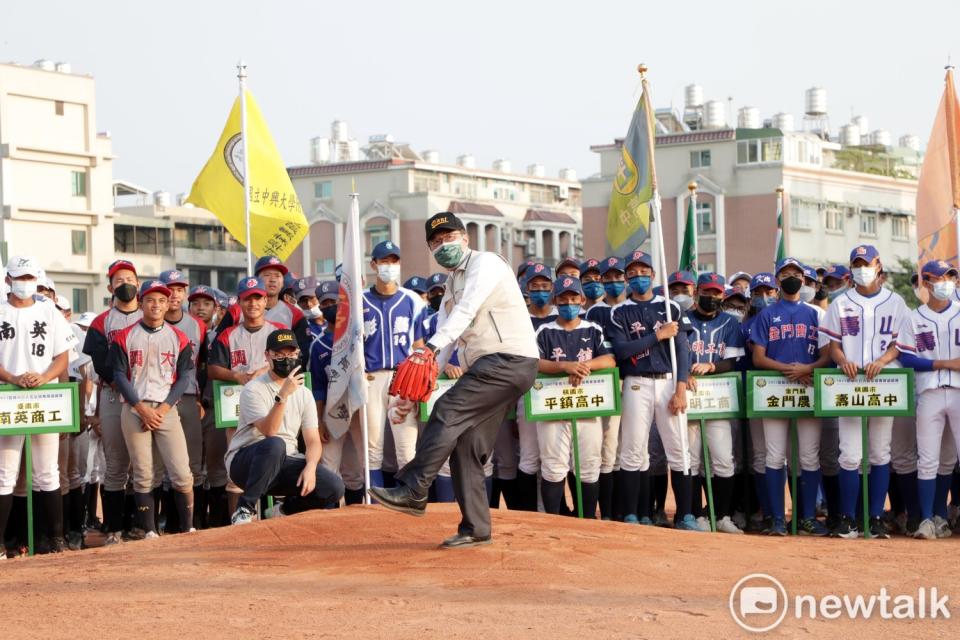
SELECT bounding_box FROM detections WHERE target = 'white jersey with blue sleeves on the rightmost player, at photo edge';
[897,301,960,395]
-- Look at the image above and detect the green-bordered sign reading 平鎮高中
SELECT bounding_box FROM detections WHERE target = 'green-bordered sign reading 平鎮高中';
[524,369,620,422]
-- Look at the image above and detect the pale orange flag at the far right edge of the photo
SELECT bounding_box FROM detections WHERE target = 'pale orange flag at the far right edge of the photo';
[917,68,960,265]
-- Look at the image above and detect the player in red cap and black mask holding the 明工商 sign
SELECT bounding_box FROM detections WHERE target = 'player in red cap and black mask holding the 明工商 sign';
[687,273,745,533]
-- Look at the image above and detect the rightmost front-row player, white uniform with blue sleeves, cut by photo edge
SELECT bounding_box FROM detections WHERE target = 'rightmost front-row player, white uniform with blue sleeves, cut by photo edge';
[897,260,960,540]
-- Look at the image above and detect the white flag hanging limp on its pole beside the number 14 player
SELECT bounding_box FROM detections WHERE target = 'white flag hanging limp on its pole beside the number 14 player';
[324,193,367,440]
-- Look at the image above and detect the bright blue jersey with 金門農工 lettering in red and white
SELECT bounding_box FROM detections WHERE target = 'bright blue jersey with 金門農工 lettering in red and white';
[750,300,820,364]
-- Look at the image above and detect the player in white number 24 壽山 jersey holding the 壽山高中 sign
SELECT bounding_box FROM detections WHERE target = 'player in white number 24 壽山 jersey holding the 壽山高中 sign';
[820,245,909,538]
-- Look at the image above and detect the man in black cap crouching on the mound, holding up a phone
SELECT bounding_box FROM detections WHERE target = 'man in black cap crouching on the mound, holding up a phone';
[225,329,343,525]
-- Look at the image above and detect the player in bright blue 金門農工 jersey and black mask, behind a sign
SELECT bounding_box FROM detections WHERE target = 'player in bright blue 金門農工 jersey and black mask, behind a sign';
[750,258,830,536]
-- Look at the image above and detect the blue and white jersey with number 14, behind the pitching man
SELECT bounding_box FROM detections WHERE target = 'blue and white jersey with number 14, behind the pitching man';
[363,287,426,371]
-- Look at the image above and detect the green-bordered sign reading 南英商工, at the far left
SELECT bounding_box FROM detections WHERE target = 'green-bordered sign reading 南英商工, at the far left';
[0,382,80,436]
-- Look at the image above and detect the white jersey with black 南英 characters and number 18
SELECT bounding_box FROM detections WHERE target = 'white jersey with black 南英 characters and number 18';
[0,300,77,376]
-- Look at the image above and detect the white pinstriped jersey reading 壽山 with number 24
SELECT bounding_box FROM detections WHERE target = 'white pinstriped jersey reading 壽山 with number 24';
[820,289,910,367]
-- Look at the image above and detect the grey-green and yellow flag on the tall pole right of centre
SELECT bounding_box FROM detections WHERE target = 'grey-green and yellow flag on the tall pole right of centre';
[607,81,656,255]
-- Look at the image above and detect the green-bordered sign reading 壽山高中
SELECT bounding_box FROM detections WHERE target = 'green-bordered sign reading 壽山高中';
[814,369,915,417]
